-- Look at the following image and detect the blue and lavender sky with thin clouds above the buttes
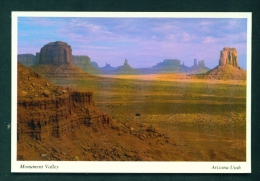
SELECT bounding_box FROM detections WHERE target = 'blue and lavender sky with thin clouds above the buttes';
[18,17,247,69]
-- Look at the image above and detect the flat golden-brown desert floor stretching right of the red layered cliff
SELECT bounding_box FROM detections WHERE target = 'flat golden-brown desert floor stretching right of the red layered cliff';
[33,74,246,161]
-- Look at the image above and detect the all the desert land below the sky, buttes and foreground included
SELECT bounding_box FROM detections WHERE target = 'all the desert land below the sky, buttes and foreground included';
[17,41,246,161]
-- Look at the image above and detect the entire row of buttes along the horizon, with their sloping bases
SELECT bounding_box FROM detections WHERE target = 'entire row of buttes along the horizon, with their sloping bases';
[18,41,242,76]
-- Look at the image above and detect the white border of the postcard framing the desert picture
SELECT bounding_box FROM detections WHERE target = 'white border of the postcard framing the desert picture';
[11,12,252,173]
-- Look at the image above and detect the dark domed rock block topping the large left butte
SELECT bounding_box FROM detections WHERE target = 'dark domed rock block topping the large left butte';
[39,41,72,65]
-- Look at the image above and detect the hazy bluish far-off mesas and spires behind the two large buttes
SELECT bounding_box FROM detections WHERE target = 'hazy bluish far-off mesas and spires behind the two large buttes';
[18,54,210,74]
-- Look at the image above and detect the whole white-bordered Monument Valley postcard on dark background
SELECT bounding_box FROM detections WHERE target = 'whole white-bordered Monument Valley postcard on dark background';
[11,12,252,173]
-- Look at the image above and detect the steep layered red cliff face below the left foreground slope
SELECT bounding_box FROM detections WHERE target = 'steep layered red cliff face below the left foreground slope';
[17,92,110,140]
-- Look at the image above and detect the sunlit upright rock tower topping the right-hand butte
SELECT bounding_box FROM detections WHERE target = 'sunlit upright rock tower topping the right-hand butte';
[219,47,238,67]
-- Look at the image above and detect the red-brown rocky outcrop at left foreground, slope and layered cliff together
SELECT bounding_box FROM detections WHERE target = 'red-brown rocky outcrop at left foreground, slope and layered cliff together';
[17,64,111,141]
